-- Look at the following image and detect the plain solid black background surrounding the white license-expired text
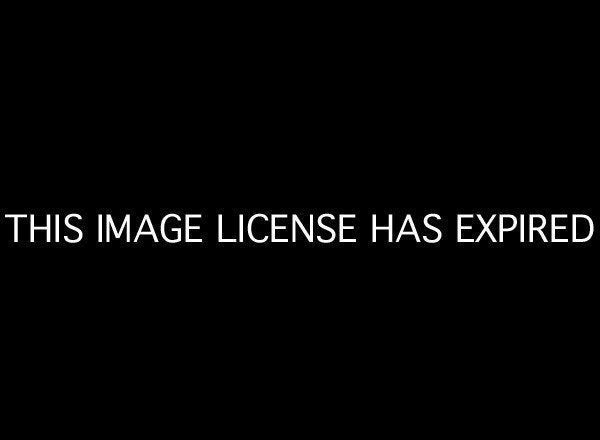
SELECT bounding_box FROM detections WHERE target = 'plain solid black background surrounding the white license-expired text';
[1,5,598,433]
